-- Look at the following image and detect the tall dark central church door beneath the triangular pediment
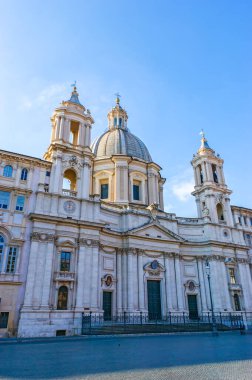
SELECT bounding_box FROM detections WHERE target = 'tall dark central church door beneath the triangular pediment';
[147,280,161,320]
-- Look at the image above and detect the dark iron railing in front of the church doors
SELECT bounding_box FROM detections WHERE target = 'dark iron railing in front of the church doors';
[82,312,245,335]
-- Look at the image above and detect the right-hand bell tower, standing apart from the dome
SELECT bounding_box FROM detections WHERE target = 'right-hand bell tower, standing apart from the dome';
[191,131,233,226]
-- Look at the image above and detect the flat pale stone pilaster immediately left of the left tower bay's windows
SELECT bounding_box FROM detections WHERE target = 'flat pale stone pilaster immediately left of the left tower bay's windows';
[41,238,54,308]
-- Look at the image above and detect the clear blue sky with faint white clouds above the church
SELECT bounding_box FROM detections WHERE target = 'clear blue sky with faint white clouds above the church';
[0,0,252,216]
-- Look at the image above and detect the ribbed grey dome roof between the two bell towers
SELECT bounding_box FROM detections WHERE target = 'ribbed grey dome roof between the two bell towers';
[91,128,152,162]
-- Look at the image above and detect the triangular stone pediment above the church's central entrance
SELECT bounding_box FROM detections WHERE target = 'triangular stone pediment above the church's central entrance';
[127,222,184,242]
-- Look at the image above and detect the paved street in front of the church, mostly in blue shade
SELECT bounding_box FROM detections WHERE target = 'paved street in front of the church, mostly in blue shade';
[0,333,252,380]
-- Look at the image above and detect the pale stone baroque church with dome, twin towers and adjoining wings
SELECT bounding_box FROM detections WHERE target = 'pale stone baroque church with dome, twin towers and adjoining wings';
[0,87,252,337]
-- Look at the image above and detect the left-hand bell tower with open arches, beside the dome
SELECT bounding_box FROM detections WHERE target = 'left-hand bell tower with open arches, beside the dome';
[44,84,94,199]
